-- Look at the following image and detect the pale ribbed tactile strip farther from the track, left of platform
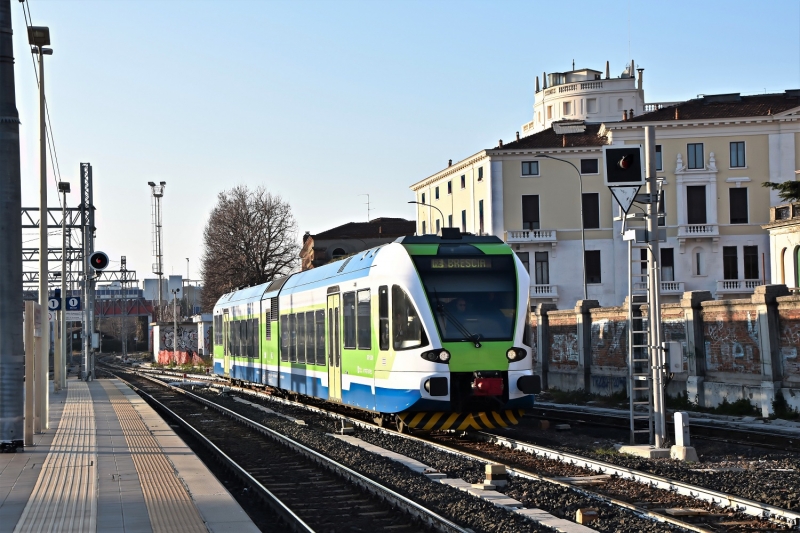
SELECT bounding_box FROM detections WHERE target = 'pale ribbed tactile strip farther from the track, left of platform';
[14,381,97,533]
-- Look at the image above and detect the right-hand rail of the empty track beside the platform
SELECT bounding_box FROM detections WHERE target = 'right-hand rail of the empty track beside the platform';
[126,368,471,533]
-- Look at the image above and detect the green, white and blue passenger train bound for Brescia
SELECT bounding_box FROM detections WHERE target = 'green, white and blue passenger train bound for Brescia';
[212,228,541,431]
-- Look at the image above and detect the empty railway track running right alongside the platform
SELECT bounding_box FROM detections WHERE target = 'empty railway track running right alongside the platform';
[106,371,467,533]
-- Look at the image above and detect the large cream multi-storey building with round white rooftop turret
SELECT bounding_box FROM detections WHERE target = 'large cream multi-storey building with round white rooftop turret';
[411,61,800,308]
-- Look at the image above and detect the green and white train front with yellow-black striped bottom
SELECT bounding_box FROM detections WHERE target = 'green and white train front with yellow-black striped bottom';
[399,235,540,430]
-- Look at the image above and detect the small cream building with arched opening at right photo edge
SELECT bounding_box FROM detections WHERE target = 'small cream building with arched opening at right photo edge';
[762,203,800,291]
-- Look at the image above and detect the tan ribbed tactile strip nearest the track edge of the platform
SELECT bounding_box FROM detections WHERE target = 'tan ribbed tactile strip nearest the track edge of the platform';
[101,381,208,533]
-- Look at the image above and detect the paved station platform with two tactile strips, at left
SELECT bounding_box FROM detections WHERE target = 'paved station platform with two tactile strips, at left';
[0,379,259,533]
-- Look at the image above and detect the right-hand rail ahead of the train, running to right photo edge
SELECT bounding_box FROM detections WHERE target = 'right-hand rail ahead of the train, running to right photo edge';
[478,432,800,527]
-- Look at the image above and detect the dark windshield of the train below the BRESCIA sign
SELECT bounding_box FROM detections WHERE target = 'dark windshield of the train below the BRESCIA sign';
[414,255,517,342]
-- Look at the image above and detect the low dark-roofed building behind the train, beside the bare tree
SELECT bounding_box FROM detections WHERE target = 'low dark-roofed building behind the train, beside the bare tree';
[300,217,416,270]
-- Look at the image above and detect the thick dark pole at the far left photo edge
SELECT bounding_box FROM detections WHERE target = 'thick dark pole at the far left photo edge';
[0,0,25,452]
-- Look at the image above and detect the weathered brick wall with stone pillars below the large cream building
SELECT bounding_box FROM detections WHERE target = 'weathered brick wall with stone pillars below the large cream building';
[531,285,800,416]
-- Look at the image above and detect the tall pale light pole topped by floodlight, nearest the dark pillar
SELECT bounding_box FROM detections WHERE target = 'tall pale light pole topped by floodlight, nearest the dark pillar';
[28,26,53,429]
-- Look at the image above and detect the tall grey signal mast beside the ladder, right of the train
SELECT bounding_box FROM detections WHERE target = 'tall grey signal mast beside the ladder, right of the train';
[644,126,667,448]
